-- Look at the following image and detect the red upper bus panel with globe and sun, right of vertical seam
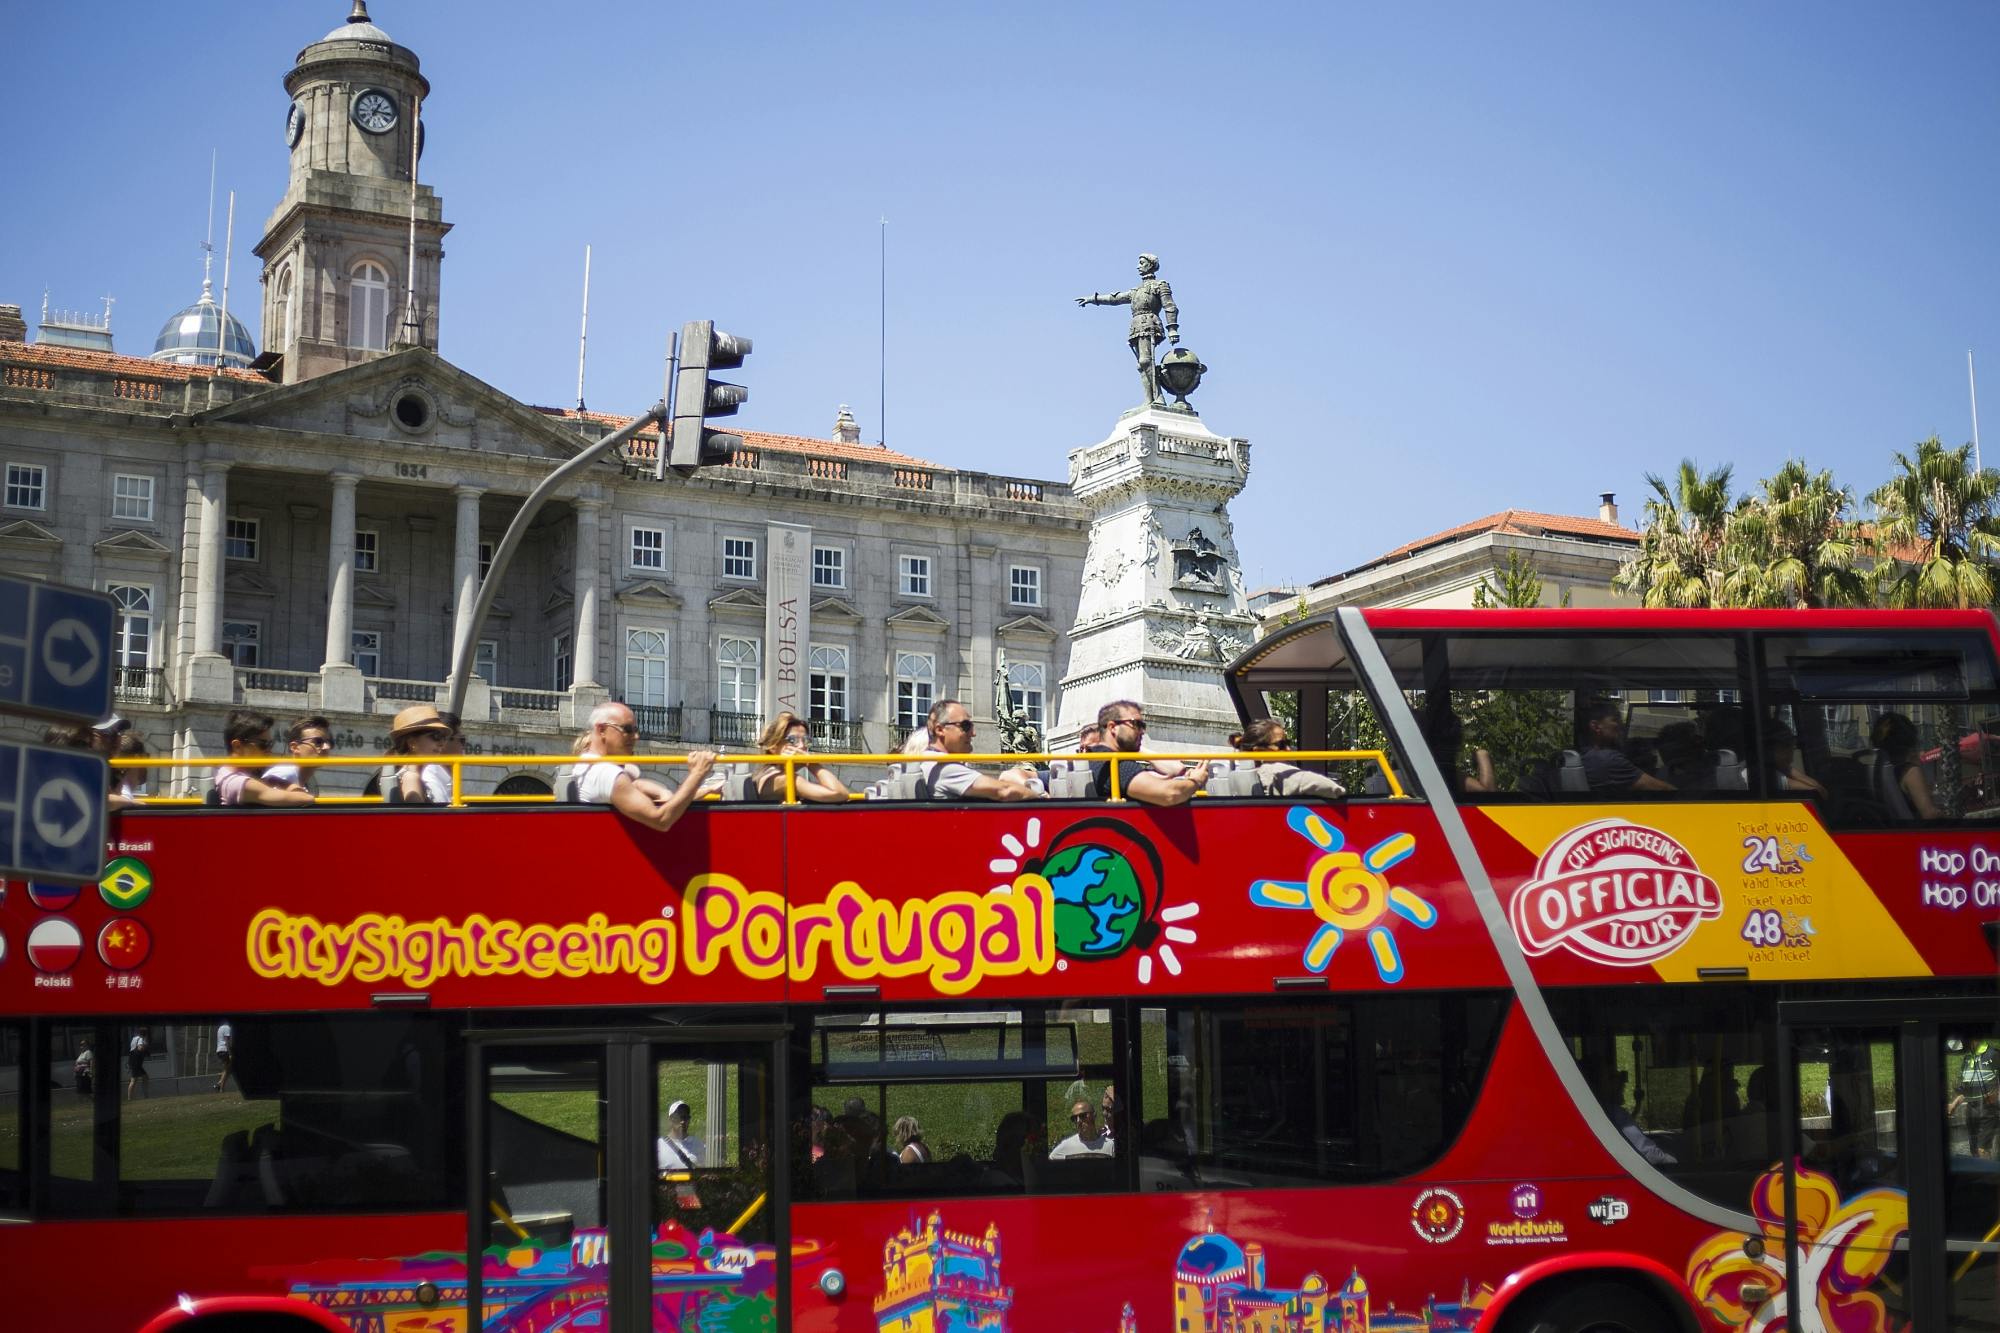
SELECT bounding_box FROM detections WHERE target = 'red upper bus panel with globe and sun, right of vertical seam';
[786,801,1504,1003]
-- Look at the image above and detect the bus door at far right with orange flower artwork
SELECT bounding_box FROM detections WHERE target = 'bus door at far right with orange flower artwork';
[1778,1001,2000,1333]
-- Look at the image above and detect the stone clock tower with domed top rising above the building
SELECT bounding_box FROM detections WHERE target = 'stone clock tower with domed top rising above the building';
[256,0,450,384]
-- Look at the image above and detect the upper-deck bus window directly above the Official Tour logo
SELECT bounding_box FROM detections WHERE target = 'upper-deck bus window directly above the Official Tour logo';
[1380,630,1752,801]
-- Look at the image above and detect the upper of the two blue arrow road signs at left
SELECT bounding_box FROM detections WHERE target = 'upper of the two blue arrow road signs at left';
[0,576,118,723]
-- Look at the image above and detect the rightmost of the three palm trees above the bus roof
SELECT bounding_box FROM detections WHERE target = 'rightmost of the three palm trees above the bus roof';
[1868,436,2000,608]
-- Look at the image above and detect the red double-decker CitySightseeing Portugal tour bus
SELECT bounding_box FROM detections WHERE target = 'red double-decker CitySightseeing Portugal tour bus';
[0,610,2000,1333]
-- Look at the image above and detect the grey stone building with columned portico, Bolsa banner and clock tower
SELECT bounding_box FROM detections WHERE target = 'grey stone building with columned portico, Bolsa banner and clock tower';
[0,4,1088,791]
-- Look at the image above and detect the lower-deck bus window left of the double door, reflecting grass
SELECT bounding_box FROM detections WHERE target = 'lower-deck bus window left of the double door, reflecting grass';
[50,1015,458,1215]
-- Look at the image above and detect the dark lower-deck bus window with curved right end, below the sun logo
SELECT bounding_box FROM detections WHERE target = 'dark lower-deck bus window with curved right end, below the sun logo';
[1134,991,1506,1193]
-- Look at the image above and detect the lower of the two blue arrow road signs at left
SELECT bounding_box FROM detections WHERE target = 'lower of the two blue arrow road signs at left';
[0,745,108,881]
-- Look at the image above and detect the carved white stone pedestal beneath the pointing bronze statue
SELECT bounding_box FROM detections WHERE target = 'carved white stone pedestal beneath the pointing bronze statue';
[1050,408,1256,751]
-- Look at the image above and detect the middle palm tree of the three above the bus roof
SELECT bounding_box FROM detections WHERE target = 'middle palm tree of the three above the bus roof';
[1722,458,1868,606]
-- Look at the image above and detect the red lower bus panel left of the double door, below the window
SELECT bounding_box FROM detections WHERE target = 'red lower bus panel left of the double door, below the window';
[0,1213,466,1333]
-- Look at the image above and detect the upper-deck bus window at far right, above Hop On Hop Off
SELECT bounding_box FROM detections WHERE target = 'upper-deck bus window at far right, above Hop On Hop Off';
[1760,630,2000,829]
